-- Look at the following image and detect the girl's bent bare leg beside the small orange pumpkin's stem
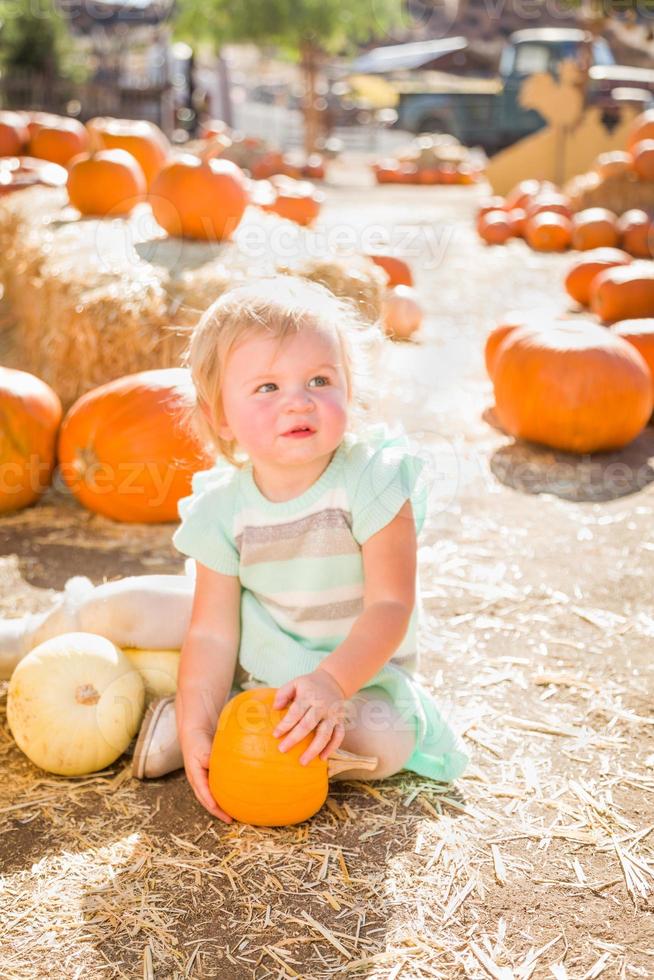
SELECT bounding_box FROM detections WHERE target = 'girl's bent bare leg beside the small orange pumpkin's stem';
[332,688,416,781]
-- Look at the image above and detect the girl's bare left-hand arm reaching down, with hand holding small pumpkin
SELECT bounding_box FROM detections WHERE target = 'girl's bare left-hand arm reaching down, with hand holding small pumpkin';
[175,562,241,819]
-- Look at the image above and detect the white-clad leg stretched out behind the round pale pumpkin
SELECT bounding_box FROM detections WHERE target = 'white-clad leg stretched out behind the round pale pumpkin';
[0,575,194,678]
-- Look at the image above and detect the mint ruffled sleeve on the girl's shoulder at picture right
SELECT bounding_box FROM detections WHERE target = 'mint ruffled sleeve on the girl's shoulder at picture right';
[345,422,430,544]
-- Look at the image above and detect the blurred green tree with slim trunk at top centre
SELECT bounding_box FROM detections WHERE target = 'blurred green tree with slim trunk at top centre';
[178,0,403,152]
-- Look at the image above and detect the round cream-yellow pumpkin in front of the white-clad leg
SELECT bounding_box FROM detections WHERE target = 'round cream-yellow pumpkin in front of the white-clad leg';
[7,633,145,776]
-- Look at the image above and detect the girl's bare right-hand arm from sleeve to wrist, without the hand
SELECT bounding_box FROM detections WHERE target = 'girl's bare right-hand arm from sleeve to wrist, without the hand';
[319,500,417,699]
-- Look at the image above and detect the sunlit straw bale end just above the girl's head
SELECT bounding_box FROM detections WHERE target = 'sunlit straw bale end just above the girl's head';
[278,255,386,323]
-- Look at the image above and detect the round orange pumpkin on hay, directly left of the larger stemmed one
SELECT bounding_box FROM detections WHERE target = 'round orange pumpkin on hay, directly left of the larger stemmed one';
[67,150,145,215]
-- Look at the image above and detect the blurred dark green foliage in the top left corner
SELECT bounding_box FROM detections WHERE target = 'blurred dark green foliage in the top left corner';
[0,0,84,78]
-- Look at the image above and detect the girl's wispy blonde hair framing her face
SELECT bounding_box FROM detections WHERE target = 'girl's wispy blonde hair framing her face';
[183,275,388,467]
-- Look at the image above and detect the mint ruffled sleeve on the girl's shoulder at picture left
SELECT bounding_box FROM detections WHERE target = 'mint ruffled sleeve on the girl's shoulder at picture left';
[173,460,239,575]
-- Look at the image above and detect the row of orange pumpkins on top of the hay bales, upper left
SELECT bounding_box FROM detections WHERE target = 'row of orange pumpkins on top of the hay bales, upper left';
[0,112,322,235]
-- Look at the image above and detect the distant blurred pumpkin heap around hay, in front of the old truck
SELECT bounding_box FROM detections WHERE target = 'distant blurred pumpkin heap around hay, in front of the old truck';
[372,134,485,186]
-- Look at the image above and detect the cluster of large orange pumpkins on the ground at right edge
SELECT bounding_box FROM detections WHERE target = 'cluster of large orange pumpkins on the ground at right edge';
[485,248,654,453]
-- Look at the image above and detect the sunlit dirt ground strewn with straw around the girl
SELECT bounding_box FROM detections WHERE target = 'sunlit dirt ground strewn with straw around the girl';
[0,175,654,980]
